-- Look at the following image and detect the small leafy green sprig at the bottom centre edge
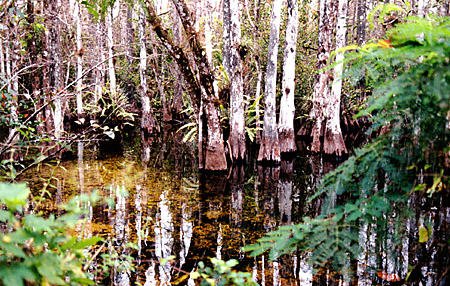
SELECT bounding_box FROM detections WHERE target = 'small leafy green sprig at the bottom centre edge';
[190,258,258,286]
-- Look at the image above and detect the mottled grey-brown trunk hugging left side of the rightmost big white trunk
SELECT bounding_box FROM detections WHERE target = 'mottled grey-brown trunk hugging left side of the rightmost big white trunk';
[311,0,336,152]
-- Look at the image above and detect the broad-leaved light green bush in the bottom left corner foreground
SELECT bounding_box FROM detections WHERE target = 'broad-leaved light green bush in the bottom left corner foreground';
[0,183,100,285]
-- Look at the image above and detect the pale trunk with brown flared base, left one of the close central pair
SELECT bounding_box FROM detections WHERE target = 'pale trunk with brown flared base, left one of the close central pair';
[258,0,283,162]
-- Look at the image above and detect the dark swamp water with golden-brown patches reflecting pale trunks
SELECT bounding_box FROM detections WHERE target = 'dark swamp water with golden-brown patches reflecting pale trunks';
[24,139,450,285]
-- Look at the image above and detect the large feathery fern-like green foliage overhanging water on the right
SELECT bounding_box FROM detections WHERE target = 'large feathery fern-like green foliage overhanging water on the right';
[245,17,450,269]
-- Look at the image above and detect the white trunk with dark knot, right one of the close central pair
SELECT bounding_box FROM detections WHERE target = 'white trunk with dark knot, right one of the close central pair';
[278,0,298,153]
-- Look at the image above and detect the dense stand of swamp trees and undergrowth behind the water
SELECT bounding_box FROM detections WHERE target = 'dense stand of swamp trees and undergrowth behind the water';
[0,1,448,170]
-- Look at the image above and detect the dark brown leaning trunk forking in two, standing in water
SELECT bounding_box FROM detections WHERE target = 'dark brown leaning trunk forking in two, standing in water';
[146,0,227,170]
